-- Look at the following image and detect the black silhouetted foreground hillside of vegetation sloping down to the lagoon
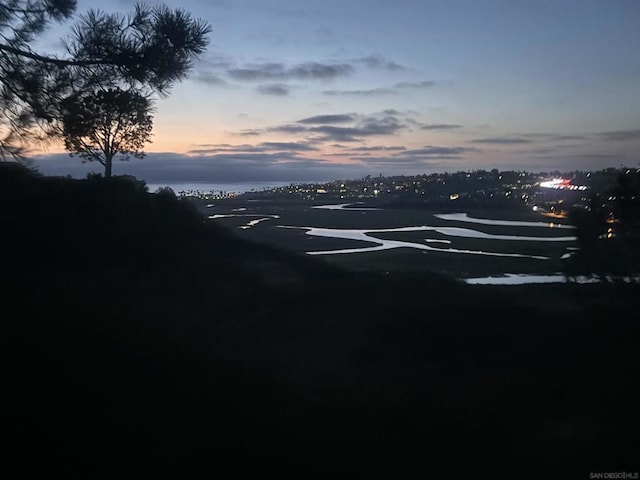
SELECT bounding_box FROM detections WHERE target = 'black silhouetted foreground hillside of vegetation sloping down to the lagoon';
[5,164,640,478]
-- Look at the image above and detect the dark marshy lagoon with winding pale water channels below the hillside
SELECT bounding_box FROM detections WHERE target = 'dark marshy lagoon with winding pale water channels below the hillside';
[210,204,576,285]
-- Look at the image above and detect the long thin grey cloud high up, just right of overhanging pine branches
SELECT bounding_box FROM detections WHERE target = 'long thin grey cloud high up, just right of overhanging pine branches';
[227,62,354,81]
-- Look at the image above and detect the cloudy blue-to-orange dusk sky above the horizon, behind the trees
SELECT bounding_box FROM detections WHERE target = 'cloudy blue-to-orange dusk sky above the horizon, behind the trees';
[28,0,640,184]
